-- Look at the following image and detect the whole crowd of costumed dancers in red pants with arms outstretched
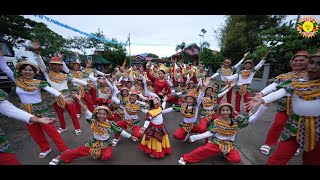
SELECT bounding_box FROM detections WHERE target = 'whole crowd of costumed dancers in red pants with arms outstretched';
[0,42,320,165]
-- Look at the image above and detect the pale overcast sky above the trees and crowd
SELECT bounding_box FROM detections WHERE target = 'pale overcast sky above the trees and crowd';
[24,15,320,57]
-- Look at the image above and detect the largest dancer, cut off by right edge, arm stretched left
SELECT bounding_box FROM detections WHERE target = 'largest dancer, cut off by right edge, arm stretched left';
[246,50,320,165]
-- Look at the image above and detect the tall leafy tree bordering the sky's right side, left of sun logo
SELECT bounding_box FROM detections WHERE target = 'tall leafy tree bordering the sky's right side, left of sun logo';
[219,15,285,60]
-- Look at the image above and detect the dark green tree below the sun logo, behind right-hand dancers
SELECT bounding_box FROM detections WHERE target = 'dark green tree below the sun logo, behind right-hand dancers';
[252,21,320,77]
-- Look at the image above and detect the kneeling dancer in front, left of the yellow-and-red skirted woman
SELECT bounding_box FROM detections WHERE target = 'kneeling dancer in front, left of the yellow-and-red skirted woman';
[49,94,138,165]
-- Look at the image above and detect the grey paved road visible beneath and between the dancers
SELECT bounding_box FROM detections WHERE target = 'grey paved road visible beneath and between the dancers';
[0,88,302,165]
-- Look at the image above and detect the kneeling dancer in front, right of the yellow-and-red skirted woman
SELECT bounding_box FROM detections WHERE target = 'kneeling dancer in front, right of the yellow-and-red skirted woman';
[178,102,267,165]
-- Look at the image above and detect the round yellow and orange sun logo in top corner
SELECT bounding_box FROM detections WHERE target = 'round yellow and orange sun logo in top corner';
[297,16,319,38]
